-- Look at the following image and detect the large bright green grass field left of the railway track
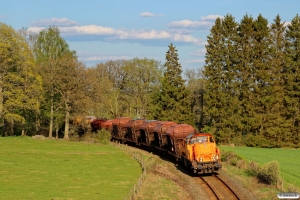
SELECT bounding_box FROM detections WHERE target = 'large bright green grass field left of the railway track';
[0,137,141,199]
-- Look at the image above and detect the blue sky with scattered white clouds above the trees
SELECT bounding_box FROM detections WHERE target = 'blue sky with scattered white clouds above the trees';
[0,0,300,71]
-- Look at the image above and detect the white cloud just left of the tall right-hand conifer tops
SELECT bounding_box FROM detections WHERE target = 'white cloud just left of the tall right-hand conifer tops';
[169,15,223,29]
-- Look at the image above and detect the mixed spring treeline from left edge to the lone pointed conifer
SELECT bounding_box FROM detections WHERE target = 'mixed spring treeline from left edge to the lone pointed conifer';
[0,23,194,139]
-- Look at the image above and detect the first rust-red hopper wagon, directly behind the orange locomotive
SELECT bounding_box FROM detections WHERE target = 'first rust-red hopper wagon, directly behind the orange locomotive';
[166,124,196,159]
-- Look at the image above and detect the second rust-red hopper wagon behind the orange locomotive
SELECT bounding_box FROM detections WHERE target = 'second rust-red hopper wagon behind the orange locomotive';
[153,121,177,150]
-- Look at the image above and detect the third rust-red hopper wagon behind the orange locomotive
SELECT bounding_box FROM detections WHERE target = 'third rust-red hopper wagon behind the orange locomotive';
[140,120,160,146]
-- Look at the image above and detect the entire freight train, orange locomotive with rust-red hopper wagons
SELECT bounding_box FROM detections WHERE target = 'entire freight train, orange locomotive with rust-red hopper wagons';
[85,117,222,174]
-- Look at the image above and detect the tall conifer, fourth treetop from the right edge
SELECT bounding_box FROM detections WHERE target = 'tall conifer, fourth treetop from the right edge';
[236,15,257,139]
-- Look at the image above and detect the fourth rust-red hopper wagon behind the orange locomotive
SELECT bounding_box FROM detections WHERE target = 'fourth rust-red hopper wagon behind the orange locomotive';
[125,119,145,144]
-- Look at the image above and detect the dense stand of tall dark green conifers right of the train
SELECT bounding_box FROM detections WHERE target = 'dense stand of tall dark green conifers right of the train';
[204,15,300,147]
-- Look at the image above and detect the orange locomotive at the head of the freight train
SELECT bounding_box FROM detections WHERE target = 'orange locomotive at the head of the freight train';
[182,133,222,173]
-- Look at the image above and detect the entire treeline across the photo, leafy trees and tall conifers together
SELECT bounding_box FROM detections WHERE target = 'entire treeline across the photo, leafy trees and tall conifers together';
[0,12,300,147]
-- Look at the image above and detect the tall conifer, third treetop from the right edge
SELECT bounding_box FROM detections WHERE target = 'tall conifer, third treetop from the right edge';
[252,15,276,147]
